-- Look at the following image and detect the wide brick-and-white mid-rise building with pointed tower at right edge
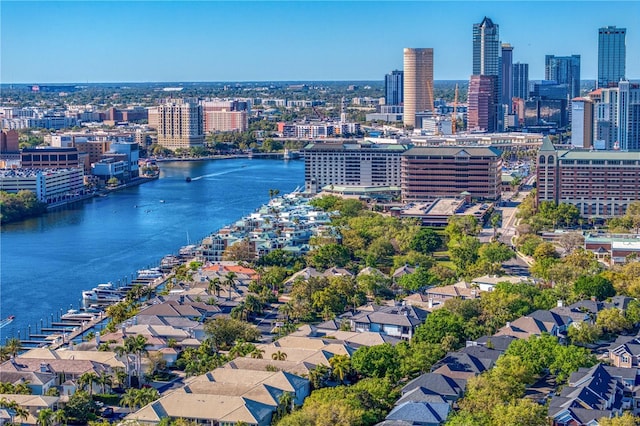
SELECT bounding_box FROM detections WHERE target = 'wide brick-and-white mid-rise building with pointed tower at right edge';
[537,138,640,217]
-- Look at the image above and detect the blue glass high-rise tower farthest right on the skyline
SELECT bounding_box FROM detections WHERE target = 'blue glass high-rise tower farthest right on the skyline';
[598,26,627,87]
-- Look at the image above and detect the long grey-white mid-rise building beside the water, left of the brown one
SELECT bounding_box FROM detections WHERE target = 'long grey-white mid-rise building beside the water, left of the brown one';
[304,143,407,193]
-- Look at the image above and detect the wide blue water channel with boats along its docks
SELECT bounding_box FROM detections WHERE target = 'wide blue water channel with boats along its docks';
[0,159,304,343]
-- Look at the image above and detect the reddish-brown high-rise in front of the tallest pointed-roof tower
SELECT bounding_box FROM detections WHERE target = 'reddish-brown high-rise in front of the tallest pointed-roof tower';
[467,75,497,133]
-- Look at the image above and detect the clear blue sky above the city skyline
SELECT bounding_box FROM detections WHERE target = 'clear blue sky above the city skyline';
[0,0,640,83]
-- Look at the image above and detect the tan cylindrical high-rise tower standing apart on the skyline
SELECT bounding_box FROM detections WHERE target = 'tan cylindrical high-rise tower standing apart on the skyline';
[404,48,433,127]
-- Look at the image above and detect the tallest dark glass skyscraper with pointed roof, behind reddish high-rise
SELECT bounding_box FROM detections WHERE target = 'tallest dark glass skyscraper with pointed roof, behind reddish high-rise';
[473,16,500,75]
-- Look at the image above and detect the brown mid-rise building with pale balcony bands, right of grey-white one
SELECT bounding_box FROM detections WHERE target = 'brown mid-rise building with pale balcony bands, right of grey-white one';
[401,146,502,202]
